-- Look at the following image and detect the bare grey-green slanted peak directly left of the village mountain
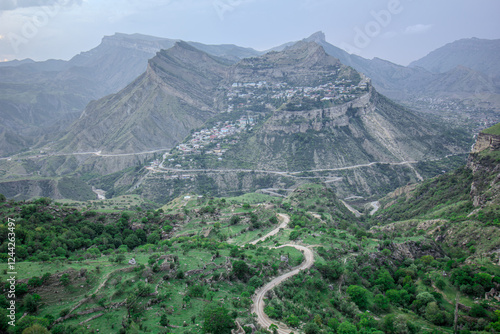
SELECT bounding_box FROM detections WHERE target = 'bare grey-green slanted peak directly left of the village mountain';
[56,42,230,153]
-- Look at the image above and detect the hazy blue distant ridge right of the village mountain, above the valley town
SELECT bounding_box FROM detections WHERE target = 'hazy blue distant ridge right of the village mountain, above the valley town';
[306,32,500,101]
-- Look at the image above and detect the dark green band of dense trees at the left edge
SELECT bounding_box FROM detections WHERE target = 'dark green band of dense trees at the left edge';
[0,198,175,261]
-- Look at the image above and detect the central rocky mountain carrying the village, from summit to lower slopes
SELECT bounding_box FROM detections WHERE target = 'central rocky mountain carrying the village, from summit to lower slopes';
[132,41,468,203]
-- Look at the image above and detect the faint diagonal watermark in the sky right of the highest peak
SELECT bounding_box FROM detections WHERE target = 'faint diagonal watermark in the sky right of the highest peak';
[340,0,412,53]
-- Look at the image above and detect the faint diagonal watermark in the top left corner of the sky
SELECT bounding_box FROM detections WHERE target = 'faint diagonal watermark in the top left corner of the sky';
[7,0,75,53]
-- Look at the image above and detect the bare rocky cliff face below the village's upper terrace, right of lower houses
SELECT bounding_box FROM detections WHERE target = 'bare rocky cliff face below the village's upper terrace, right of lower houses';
[228,84,464,171]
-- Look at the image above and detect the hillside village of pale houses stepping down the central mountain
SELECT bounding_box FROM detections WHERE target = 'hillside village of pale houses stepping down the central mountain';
[154,76,370,171]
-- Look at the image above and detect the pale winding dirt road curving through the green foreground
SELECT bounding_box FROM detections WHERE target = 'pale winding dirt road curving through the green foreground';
[251,213,314,334]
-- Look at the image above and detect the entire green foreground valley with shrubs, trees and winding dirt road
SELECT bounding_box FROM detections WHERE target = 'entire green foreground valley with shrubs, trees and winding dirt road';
[0,126,500,334]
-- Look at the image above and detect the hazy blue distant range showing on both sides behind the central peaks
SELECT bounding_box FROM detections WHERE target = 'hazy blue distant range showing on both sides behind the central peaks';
[0,32,500,156]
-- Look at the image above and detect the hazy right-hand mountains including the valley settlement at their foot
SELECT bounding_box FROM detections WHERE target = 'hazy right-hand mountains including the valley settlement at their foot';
[298,32,500,121]
